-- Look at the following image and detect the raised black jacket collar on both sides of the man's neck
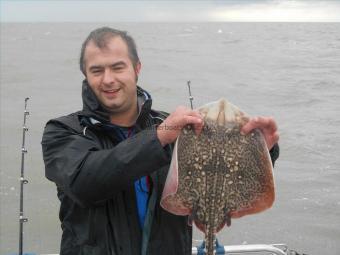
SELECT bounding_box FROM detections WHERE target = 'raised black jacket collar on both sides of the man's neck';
[81,79,152,123]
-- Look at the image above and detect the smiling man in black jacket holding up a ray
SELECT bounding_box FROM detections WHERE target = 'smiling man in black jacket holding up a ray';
[42,27,278,255]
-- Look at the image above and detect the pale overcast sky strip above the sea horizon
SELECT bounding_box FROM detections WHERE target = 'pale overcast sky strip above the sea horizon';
[0,0,340,22]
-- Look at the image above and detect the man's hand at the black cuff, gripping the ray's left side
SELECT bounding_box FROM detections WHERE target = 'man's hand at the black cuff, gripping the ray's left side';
[157,106,203,146]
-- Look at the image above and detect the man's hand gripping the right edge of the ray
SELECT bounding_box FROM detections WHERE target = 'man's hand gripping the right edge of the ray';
[241,117,279,150]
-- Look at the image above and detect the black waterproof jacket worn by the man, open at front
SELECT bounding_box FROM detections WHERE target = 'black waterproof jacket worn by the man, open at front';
[42,81,192,255]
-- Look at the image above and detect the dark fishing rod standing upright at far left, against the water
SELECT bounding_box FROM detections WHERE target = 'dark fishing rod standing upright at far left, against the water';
[19,97,29,255]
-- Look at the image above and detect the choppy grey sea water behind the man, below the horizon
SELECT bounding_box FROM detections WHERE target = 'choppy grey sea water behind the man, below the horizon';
[0,23,340,255]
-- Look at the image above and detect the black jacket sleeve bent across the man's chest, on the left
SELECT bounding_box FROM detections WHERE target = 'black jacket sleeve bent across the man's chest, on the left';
[41,122,171,206]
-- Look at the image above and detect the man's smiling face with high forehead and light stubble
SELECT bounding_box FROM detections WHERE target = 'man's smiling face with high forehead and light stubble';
[85,37,141,114]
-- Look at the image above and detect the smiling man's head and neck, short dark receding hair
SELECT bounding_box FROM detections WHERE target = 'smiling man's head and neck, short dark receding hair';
[80,27,141,121]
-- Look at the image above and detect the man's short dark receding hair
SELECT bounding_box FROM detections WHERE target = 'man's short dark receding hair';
[79,27,139,76]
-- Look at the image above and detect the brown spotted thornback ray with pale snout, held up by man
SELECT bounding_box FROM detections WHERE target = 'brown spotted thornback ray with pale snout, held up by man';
[161,99,275,255]
